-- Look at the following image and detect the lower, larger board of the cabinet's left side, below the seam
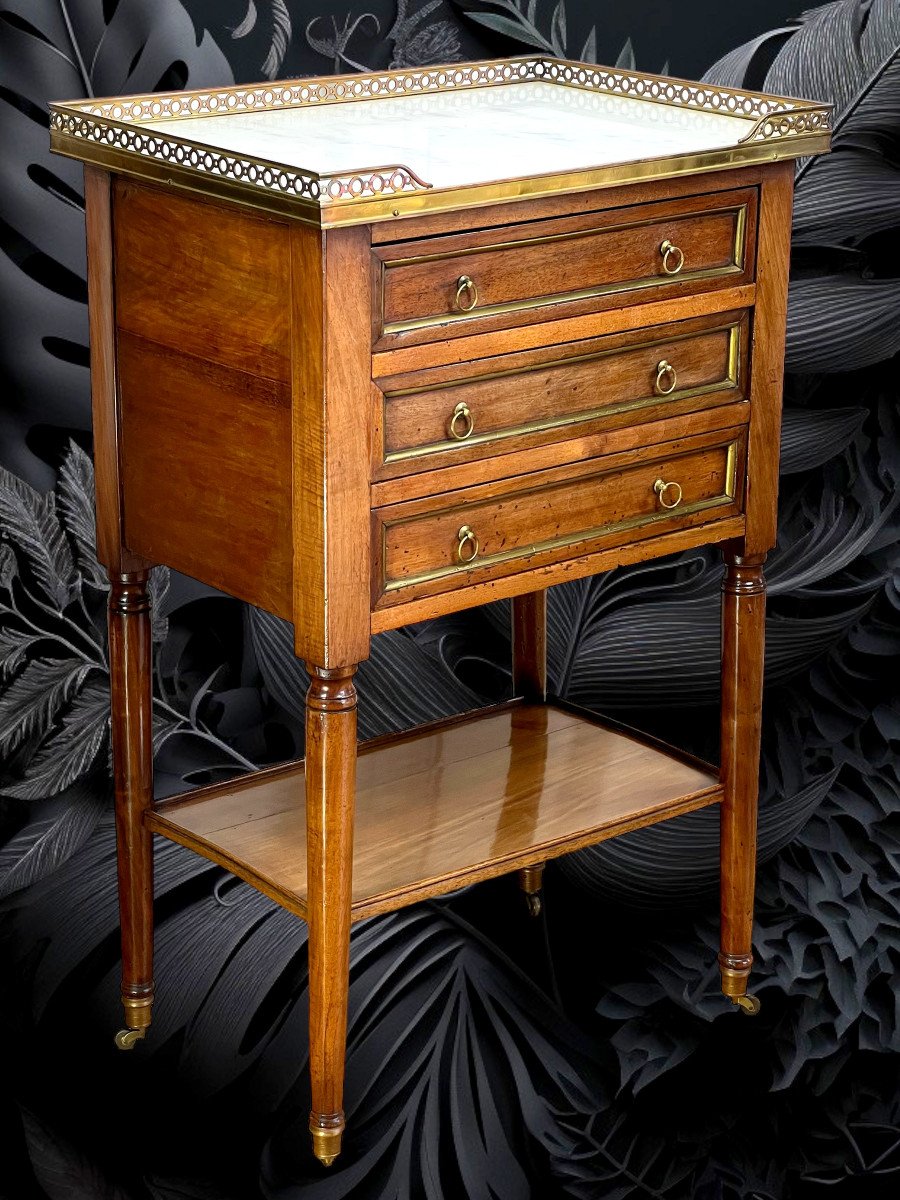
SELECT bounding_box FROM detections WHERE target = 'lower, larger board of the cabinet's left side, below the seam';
[119,334,292,618]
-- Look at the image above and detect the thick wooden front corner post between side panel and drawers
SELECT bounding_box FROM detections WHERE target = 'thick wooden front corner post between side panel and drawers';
[290,224,372,667]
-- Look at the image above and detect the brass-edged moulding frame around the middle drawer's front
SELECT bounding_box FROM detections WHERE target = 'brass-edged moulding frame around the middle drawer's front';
[382,322,740,464]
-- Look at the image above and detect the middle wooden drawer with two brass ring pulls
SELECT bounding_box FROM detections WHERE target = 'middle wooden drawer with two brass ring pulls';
[373,312,749,479]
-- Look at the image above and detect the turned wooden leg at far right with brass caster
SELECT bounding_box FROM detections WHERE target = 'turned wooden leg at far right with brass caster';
[719,553,766,1015]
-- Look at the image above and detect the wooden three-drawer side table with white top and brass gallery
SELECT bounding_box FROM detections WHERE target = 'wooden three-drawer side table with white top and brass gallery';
[52,56,829,1164]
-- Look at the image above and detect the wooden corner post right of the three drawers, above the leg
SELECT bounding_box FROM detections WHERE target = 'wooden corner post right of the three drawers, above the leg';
[744,162,794,556]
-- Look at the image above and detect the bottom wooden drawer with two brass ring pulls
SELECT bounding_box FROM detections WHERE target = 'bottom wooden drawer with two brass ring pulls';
[372,427,745,607]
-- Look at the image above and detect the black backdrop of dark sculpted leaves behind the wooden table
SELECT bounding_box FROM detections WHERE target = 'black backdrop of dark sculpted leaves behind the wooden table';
[0,0,900,1200]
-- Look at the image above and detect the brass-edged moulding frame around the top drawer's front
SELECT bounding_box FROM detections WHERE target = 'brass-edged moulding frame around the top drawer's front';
[379,203,748,336]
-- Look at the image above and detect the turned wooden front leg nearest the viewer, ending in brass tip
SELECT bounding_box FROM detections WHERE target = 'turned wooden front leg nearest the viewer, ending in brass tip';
[306,664,356,1166]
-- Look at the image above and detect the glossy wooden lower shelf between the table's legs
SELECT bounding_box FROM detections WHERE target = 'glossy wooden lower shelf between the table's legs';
[146,703,721,920]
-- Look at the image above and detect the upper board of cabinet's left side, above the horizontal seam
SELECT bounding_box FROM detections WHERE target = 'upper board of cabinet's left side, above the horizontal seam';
[115,180,290,379]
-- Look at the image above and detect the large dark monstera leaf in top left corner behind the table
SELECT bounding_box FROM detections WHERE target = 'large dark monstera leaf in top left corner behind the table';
[0,0,232,488]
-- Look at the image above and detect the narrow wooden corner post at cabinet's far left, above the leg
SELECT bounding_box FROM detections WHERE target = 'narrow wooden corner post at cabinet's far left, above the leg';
[84,166,149,574]
